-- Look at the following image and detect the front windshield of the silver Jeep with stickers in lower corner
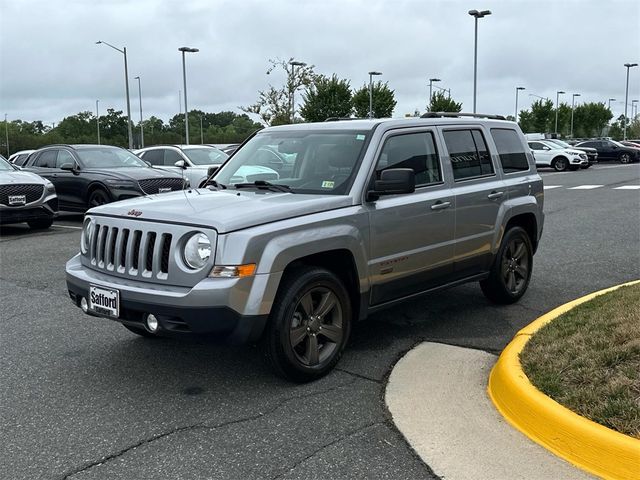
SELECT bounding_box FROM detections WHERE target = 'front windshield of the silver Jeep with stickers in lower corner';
[215,129,370,195]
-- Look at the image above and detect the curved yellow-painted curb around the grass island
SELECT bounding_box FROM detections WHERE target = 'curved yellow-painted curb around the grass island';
[488,280,640,480]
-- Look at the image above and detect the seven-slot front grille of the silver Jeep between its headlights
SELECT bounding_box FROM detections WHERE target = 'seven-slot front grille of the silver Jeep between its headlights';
[88,222,173,280]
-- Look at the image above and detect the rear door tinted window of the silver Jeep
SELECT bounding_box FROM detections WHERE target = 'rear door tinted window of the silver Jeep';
[443,130,493,180]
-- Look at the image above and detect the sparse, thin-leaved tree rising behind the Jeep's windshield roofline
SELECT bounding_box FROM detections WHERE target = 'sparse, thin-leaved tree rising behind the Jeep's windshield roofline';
[240,58,315,125]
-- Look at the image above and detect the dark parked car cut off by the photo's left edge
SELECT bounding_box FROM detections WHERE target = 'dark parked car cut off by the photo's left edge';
[0,157,58,228]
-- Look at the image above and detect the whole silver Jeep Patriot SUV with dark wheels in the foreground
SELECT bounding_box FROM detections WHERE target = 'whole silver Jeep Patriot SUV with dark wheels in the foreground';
[66,113,544,382]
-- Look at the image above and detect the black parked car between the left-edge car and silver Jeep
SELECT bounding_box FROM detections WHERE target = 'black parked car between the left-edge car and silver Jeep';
[23,145,186,212]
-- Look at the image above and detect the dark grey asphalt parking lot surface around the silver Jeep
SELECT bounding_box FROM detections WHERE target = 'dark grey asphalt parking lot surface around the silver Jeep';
[0,164,640,479]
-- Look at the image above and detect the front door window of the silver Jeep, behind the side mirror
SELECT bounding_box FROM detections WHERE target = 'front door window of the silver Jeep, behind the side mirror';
[376,132,442,185]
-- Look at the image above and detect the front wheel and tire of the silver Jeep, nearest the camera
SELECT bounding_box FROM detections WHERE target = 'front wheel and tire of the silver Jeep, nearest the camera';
[262,267,352,383]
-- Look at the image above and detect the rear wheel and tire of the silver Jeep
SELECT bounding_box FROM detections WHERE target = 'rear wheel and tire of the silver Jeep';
[480,227,533,305]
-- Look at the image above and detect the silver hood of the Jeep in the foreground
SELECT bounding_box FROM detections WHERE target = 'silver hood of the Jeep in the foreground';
[88,188,352,233]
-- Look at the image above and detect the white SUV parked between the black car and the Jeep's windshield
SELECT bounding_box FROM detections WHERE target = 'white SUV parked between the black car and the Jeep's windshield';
[135,145,229,188]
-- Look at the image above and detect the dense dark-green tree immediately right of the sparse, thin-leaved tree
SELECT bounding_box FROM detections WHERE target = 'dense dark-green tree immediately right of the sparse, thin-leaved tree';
[300,74,353,122]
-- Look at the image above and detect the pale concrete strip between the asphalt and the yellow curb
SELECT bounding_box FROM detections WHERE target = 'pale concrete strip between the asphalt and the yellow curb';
[385,342,594,480]
